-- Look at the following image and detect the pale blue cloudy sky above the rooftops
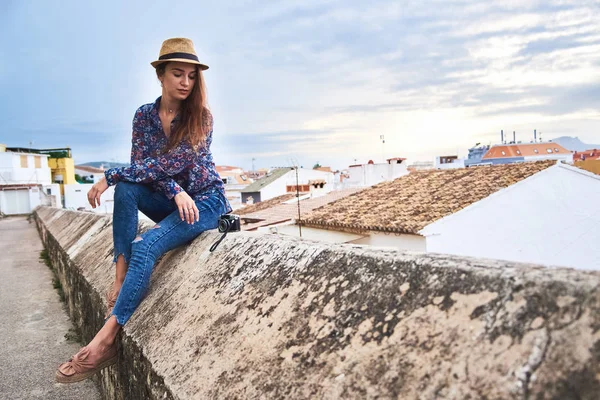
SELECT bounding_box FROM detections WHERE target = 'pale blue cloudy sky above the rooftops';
[0,0,600,169]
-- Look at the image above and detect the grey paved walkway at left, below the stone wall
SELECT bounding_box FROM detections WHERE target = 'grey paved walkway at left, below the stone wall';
[0,217,100,400]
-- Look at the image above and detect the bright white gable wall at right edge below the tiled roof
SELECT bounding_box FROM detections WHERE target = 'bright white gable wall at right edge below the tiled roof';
[420,165,600,270]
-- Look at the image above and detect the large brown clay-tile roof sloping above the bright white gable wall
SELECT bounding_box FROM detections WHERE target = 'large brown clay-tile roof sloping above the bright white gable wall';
[302,160,556,234]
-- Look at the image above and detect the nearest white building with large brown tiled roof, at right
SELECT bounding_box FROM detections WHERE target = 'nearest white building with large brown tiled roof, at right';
[302,161,600,270]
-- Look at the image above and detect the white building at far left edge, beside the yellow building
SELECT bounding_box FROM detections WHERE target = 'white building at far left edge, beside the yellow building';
[0,145,62,215]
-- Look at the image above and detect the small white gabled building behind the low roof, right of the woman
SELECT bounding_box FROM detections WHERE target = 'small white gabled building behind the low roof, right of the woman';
[241,167,334,204]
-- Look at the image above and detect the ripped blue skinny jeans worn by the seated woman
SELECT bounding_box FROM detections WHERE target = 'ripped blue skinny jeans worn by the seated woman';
[112,182,229,325]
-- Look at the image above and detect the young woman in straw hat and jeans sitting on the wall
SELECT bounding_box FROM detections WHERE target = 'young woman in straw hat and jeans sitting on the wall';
[56,38,231,383]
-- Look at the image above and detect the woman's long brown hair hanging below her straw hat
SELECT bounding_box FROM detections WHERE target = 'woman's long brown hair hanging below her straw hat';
[156,62,212,152]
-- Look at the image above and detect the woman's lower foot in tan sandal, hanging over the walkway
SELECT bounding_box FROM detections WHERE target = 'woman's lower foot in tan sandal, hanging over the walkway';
[54,343,118,383]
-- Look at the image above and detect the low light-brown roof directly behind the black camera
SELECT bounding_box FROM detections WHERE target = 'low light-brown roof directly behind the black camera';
[236,188,363,231]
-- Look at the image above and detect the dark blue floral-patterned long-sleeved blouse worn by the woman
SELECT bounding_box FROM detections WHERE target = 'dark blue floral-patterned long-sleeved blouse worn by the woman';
[104,97,231,212]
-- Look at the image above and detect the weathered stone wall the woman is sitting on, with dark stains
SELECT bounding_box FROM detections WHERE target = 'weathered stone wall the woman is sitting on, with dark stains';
[37,208,600,399]
